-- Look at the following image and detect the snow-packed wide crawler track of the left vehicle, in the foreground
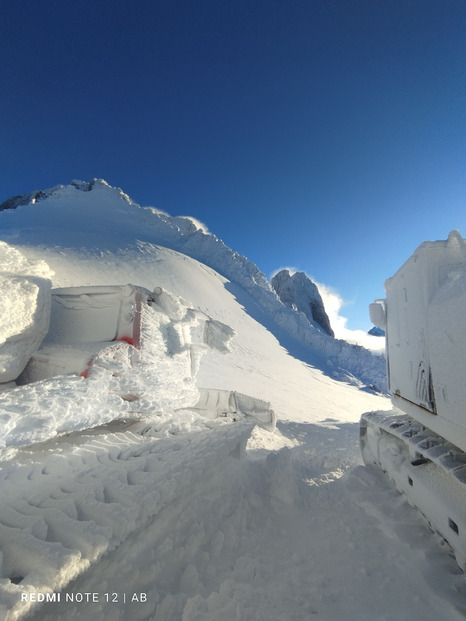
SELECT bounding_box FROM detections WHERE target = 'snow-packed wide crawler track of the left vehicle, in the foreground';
[0,413,253,621]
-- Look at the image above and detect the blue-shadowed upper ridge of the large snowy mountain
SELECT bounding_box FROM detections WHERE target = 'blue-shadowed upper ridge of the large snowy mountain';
[0,179,386,390]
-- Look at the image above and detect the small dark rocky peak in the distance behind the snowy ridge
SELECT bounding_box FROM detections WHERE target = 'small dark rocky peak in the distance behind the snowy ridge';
[270,270,335,336]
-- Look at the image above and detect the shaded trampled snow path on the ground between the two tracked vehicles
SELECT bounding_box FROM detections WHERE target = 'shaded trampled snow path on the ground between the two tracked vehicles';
[29,421,466,621]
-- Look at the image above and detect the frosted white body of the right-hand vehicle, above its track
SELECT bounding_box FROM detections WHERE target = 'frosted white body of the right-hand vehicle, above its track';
[385,231,466,446]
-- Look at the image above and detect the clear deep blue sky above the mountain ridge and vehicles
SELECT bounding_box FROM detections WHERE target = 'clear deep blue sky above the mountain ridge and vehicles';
[0,0,466,329]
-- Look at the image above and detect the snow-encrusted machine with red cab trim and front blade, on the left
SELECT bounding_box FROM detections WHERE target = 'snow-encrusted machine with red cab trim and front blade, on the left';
[0,279,275,429]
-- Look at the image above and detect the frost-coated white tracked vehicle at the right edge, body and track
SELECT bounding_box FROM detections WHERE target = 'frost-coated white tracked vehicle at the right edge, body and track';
[360,231,466,569]
